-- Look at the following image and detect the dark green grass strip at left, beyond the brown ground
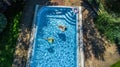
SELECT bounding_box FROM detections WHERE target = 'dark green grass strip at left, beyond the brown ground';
[0,12,22,67]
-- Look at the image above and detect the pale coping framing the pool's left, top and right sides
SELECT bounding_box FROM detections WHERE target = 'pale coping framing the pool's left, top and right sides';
[26,5,84,67]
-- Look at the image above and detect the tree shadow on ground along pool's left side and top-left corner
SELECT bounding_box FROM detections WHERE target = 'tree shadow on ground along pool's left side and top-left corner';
[12,0,58,67]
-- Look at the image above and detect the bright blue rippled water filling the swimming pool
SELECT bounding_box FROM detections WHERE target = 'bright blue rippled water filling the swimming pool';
[30,7,78,67]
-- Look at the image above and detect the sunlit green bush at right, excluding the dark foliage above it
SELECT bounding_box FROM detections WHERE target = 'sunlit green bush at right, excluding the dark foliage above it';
[95,2,120,42]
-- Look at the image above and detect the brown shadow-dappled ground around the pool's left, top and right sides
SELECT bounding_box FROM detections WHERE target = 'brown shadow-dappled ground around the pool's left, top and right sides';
[12,0,120,67]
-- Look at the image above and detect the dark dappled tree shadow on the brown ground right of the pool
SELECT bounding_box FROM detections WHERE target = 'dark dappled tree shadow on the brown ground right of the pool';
[82,1,106,61]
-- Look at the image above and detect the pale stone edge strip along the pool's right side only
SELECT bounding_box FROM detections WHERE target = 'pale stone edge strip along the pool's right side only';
[78,7,85,67]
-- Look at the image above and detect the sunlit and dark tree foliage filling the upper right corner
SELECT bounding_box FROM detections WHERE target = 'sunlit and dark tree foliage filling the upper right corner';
[86,0,120,43]
